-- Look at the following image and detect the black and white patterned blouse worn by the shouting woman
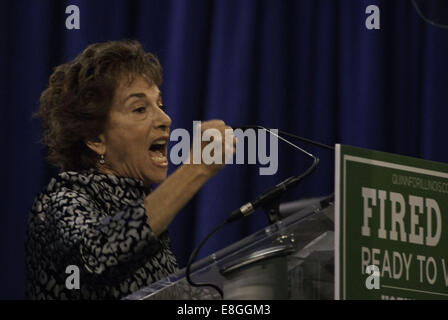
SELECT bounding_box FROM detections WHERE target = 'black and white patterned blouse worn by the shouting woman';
[26,170,177,299]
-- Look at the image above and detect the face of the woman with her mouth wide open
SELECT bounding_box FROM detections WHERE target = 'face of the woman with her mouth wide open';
[100,77,171,184]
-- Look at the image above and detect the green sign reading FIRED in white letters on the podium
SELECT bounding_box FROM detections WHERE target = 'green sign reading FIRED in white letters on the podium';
[335,145,448,299]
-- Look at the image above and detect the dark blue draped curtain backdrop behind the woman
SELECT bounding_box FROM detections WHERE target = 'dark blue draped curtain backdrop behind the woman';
[0,0,448,299]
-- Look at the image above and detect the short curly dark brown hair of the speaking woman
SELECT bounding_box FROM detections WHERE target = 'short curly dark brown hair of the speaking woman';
[35,41,162,171]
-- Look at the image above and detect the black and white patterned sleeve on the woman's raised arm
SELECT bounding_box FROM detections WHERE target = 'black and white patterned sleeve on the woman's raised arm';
[51,191,160,275]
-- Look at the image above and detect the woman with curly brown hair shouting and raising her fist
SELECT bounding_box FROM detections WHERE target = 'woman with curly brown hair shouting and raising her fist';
[26,41,235,299]
